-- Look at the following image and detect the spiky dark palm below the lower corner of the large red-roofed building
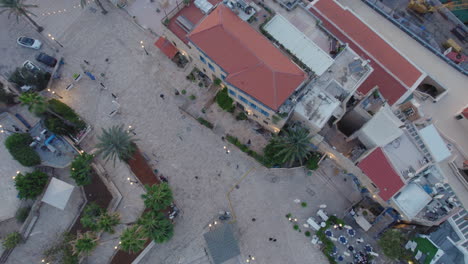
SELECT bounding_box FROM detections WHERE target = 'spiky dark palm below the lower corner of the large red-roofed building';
[271,127,312,166]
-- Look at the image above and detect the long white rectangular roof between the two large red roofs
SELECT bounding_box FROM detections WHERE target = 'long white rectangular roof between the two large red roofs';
[264,15,334,76]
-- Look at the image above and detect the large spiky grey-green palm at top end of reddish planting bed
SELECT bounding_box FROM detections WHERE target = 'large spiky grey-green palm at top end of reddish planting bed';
[96,125,136,165]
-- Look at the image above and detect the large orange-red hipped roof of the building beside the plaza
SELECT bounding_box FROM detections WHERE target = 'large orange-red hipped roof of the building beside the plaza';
[188,4,306,110]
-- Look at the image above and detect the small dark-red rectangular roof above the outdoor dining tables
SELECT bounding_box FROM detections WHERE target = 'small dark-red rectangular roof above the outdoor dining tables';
[358,148,405,201]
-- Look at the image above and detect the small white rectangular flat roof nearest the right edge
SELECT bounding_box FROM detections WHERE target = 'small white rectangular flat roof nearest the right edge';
[419,125,452,162]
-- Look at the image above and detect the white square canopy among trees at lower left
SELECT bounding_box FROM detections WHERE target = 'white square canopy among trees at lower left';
[42,177,74,210]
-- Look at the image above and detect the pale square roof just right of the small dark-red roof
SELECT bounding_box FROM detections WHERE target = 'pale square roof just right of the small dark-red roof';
[394,183,432,219]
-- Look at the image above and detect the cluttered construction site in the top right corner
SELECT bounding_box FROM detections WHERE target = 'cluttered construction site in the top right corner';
[366,0,468,71]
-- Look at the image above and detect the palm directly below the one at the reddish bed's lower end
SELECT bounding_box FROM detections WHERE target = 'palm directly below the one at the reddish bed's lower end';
[138,211,174,243]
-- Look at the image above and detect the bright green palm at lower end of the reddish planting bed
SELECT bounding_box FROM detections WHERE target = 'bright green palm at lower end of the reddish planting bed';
[141,182,173,211]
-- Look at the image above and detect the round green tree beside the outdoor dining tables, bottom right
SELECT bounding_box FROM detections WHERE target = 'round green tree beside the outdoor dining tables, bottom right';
[379,229,408,260]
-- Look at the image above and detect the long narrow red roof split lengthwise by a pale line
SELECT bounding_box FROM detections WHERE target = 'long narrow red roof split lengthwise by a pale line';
[310,0,423,105]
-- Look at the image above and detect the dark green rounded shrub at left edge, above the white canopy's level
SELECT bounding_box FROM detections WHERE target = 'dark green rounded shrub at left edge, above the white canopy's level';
[5,133,41,167]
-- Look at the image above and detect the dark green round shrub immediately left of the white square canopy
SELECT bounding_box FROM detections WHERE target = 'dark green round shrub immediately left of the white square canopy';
[15,170,48,199]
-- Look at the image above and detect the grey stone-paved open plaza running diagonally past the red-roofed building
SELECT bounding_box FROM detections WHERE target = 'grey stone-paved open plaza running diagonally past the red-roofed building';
[0,0,392,264]
